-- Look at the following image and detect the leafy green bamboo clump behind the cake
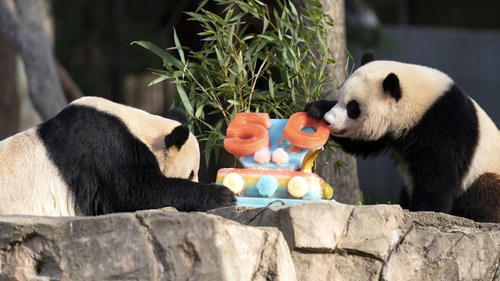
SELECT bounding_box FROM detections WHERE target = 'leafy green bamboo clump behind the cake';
[133,0,341,165]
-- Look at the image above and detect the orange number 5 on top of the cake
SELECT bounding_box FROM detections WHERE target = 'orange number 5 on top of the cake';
[224,113,271,156]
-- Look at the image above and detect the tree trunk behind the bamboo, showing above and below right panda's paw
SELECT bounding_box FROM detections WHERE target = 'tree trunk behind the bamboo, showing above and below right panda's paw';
[318,0,362,204]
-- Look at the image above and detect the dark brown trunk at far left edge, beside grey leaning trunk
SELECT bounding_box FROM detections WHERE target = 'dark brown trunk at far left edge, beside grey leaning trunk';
[0,32,19,140]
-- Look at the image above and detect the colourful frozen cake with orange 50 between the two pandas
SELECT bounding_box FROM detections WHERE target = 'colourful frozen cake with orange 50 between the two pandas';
[217,112,333,207]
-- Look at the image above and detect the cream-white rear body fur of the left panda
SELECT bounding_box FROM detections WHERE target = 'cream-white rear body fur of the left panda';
[0,128,75,216]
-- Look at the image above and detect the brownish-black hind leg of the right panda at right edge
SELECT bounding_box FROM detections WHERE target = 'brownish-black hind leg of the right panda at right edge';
[451,173,500,223]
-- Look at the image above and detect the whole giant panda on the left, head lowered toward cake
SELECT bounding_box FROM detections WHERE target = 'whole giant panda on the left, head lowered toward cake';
[0,97,236,216]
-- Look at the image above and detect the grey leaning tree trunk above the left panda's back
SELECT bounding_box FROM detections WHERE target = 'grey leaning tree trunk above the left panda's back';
[0,0,68,120]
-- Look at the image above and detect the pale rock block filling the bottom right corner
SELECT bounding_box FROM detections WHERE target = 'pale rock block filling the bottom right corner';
[381,212,500,280]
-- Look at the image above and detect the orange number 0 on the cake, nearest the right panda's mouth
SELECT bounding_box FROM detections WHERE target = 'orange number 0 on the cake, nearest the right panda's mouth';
[284,112,330,149]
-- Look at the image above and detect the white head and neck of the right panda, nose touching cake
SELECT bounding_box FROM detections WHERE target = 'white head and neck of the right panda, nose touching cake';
[324,50,453,141]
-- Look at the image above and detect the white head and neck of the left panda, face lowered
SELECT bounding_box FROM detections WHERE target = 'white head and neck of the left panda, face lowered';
[72,97,200,181]
